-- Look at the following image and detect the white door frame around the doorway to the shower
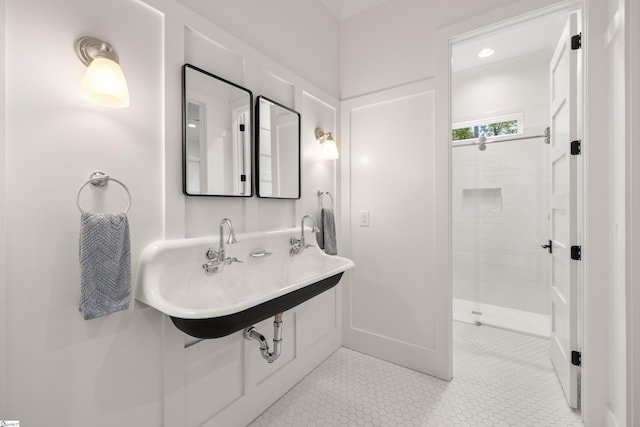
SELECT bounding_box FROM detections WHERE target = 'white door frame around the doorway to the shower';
[435,0,610,425]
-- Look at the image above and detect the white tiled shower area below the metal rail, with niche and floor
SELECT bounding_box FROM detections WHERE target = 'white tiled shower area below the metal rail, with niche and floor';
[452,130,550,336]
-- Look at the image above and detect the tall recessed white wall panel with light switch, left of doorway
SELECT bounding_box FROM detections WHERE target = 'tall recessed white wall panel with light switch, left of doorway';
[350,93,436,348]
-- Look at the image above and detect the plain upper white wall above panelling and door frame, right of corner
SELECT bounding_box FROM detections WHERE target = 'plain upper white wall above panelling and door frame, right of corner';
[340,0,511,99]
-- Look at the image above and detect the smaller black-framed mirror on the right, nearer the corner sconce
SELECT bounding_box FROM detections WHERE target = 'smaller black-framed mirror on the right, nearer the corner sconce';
[256,96,300,199]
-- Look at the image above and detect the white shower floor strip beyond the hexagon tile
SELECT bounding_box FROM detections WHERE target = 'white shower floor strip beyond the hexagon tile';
[453,298,550,338]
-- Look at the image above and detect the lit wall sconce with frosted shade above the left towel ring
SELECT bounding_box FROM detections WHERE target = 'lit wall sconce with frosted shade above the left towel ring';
[75,36,129,108]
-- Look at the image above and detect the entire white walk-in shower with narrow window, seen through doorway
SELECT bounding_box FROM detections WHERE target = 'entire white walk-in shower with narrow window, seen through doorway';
[451,25,566,336]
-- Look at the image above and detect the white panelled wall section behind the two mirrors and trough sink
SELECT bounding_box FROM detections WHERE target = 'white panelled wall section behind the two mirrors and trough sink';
[158,1,341,427]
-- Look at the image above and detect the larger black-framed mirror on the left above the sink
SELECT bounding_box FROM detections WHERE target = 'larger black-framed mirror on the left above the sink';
[182,64,253,197]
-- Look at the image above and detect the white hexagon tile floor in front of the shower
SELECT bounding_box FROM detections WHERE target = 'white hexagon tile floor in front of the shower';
[249,322,583,427]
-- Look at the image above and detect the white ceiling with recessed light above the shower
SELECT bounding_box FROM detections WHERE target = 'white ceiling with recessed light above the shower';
[451,12,567,73]
